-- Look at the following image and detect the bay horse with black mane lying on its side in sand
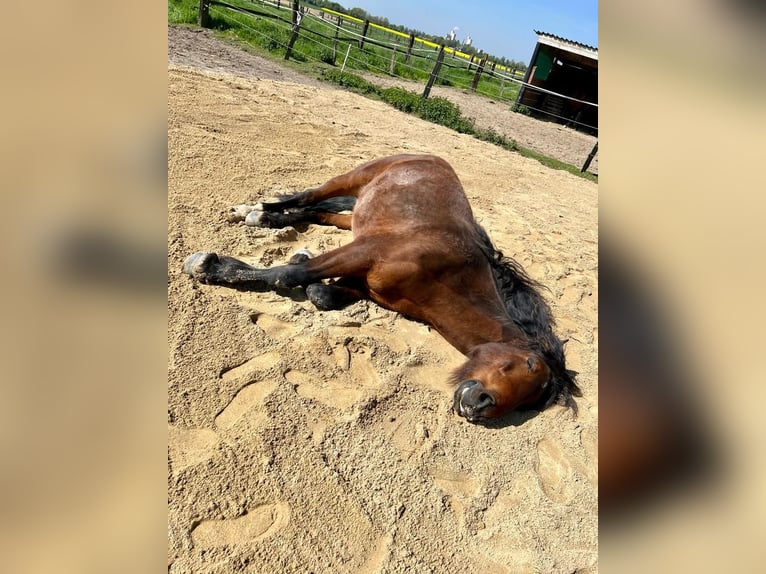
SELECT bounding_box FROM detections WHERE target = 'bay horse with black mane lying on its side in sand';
[183,155,581,422]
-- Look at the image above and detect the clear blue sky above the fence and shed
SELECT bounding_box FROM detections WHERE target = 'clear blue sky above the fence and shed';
[336,0,598,62]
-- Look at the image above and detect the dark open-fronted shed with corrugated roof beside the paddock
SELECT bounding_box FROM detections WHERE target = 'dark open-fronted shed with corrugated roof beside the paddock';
[516,30,598,135]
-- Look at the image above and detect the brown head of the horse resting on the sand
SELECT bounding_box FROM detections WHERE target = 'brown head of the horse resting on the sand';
[452,343,552,422]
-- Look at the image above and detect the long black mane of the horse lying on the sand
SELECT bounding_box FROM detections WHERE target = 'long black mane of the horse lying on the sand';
[475,223,582,414]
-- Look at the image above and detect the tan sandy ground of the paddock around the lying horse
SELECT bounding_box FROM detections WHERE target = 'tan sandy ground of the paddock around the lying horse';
[168,28,598,573]
